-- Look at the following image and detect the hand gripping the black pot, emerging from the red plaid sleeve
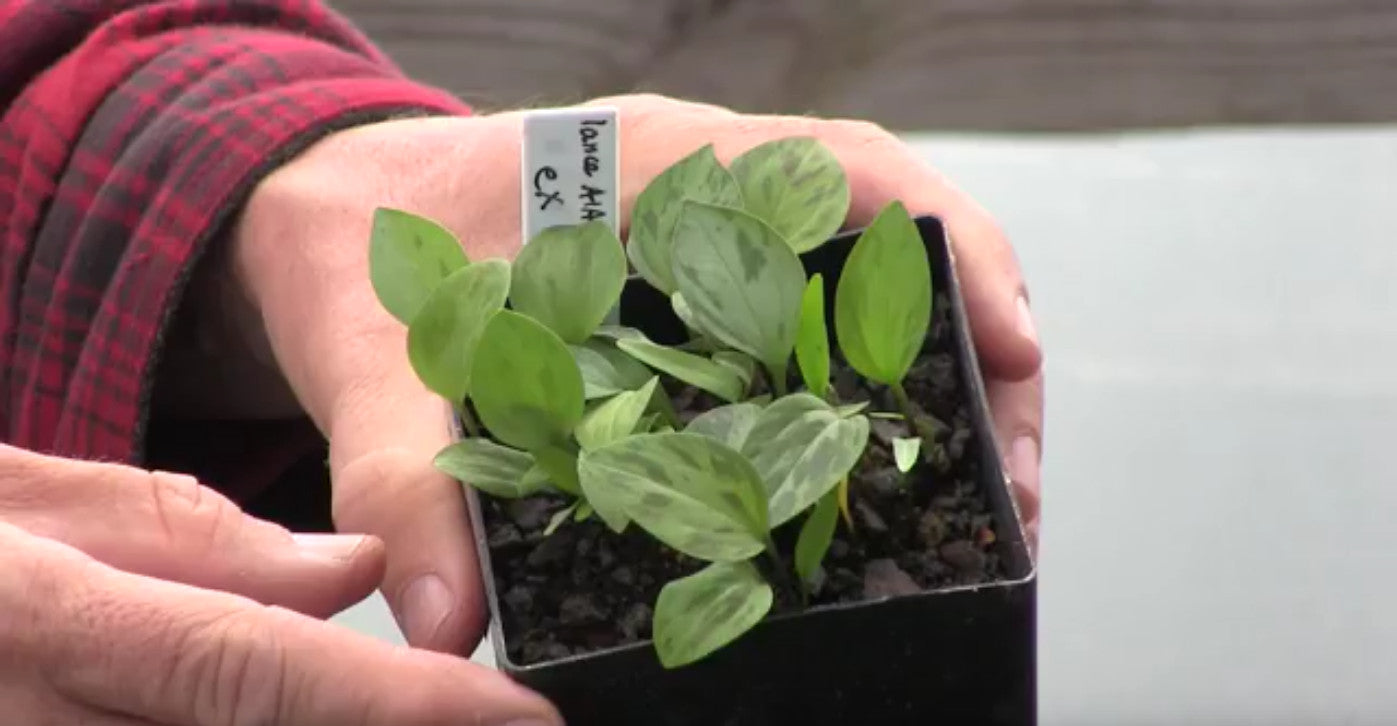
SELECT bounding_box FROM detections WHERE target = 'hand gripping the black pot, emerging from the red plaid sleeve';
[220,96,1042,652]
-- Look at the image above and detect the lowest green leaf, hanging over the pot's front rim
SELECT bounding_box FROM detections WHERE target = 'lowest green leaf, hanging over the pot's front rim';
[654,563,775,669]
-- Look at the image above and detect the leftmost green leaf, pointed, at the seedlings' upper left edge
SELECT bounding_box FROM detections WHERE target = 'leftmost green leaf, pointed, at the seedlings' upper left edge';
[369,207,468,325]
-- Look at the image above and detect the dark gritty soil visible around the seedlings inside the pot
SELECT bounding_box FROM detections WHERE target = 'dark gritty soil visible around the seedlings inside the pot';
[481,296,1003,665]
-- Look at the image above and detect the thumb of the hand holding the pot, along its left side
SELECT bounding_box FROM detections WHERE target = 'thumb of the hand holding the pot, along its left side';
[322,357,485,653]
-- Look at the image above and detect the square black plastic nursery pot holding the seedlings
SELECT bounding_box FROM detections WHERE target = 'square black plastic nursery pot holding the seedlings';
[467,218,1037,726]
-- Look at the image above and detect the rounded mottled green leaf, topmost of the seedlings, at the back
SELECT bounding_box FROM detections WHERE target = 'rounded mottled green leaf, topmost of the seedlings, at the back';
[732,137,849,253]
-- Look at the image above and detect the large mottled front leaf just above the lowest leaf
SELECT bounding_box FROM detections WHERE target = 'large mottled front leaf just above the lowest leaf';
[580,433,767,561]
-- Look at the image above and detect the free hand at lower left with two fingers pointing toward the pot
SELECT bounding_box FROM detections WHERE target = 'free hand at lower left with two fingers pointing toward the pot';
[0,445,560,726]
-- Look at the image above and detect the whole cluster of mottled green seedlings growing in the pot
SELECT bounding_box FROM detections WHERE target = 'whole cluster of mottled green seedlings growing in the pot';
[370,137,935,667]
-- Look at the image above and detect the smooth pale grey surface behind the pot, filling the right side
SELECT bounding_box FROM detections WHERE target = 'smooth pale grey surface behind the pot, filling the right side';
[332,128,1397,726]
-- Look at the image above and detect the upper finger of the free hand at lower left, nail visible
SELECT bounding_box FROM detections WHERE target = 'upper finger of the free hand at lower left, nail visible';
[0,447,383,617]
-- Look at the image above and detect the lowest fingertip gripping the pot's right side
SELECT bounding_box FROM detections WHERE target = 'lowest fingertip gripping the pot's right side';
[986,371,1044,547]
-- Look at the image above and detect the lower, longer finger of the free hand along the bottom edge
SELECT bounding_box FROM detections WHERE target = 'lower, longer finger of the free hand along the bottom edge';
[0,526,560,726]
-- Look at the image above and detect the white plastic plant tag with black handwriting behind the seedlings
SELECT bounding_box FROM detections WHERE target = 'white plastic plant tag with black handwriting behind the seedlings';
[520,106,620,244]
